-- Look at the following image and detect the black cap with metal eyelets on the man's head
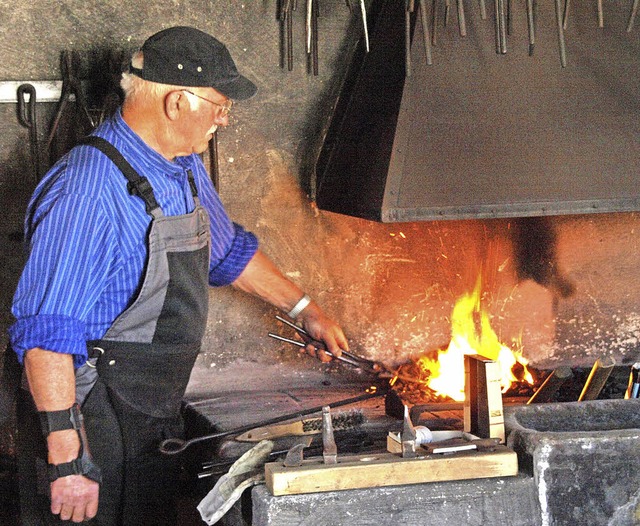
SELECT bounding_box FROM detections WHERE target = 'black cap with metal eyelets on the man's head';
[129,26,258,100]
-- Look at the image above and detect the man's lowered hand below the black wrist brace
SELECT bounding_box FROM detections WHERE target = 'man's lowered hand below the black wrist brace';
[51,475,100,522]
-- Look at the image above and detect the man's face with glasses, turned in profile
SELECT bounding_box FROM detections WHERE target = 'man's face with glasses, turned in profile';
[178,88,231,155]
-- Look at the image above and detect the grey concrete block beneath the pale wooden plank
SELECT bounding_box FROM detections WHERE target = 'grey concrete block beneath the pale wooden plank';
[248,475,541,526]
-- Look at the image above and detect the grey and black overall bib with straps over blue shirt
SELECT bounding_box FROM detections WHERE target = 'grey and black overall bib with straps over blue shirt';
[76,137,210,418]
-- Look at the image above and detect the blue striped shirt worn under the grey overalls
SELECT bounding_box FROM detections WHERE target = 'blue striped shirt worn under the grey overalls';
[9,111,258,367]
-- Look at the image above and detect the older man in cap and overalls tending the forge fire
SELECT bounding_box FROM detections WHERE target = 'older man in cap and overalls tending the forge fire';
[10,27,347,526]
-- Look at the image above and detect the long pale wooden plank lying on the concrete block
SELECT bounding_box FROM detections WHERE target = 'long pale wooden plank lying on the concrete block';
[265,446,518,496]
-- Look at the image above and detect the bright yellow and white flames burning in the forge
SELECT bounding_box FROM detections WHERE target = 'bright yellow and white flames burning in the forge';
[402,279,533,401]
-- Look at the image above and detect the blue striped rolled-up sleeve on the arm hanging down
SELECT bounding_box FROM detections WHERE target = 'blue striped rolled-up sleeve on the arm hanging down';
[9,194,113,367]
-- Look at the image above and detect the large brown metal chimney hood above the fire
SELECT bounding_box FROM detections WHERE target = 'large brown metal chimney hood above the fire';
[315,0,640,222]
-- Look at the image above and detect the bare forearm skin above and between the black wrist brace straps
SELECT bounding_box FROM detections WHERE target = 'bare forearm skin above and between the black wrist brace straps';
[24,348,80,464]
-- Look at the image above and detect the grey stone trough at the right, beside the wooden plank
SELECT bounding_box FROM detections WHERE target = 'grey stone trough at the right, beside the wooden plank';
[505,400,640,526]
